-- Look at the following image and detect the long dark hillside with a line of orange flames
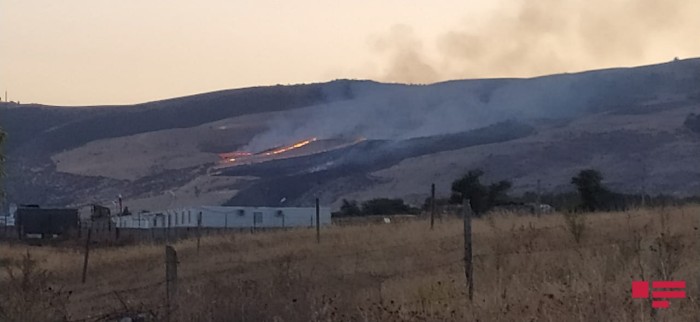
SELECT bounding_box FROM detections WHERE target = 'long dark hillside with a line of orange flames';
[0,59,700,209]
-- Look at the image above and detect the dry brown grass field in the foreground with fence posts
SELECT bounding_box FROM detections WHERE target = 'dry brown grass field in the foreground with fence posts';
[0,206,700,321]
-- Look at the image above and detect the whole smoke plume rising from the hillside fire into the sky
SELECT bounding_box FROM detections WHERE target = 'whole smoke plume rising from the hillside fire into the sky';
[242,0,700,151]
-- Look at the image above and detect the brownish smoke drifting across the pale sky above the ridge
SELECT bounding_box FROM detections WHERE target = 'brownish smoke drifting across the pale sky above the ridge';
[369,0,700,83]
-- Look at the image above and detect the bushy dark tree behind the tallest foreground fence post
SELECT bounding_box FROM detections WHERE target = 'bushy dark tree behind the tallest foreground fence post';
[450,169,511,215]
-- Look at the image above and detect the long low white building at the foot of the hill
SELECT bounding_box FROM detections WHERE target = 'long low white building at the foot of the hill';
[112,206,331,229]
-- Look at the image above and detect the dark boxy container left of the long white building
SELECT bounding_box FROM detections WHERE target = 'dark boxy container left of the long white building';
[15,206,78,238]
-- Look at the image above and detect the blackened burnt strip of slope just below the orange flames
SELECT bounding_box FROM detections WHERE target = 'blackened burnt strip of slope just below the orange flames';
[222,121,534,206]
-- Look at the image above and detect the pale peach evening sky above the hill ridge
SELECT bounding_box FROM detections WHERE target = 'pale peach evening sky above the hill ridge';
[0,0,700,106]
